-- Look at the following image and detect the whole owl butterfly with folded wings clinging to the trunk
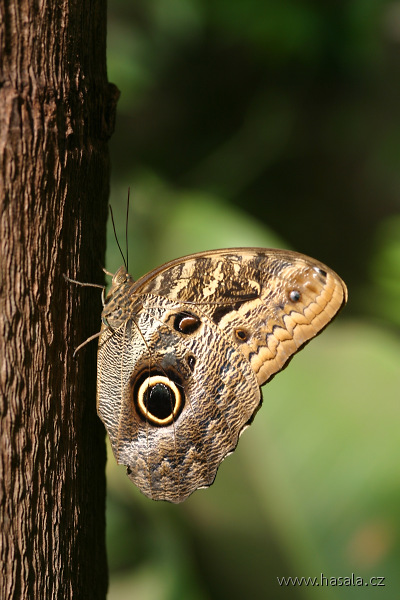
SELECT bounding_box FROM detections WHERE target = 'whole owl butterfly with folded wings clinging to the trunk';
[97,248,347,503]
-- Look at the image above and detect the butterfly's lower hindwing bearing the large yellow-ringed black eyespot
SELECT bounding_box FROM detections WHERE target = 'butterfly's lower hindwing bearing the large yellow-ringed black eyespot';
[108,297,261,503]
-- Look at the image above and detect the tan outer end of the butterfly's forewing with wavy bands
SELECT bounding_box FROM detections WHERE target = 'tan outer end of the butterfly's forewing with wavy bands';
[222,253,347,385]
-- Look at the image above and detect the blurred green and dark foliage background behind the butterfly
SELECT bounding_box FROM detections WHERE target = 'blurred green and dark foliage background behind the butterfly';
[107,0,400,600]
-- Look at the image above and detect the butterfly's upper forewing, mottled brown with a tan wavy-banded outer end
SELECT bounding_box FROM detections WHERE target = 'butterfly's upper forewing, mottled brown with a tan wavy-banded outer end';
[132,248,347,385]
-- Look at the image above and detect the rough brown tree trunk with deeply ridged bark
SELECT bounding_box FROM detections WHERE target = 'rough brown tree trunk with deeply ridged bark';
[0,0,117,600]
